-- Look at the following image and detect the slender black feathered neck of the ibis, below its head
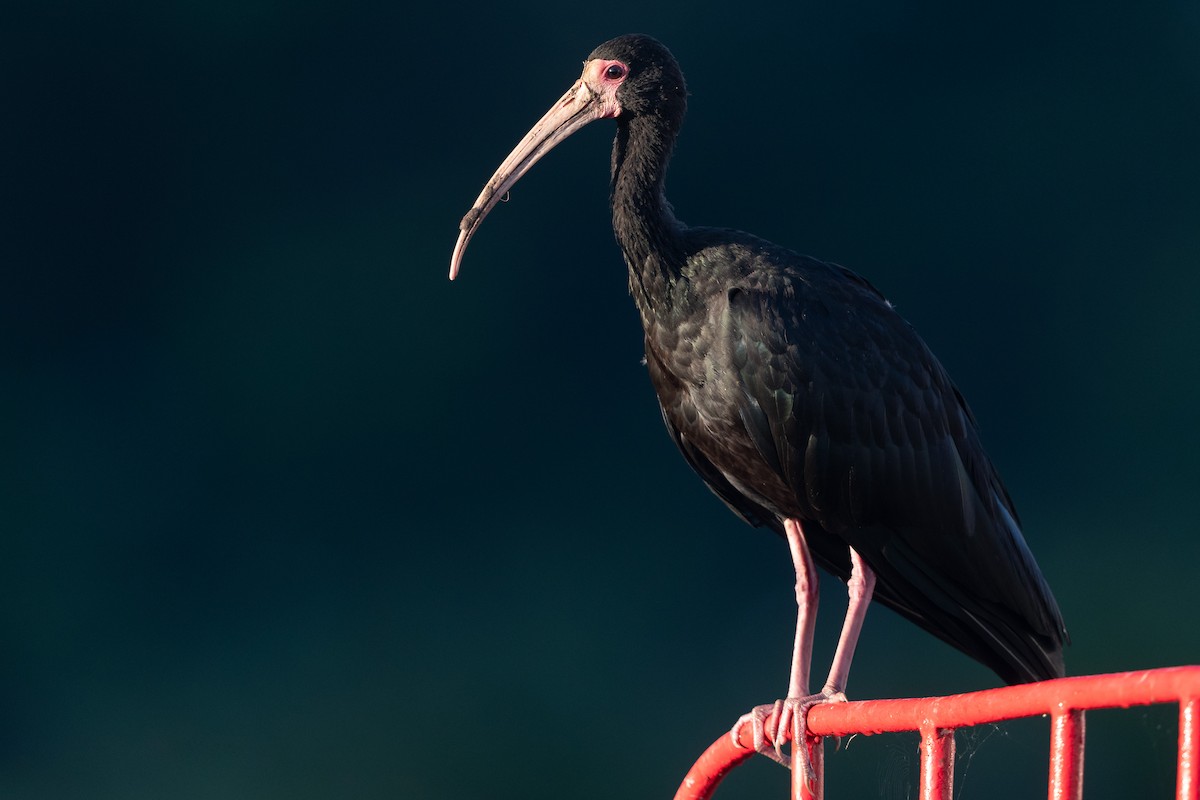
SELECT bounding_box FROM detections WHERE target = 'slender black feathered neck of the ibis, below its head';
[612,116,686,317]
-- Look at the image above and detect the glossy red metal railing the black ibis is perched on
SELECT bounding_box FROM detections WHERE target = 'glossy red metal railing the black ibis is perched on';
[676,666,1200,800]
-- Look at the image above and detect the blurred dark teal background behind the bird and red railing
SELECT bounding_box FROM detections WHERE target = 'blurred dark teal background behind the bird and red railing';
[0,0,1200,800]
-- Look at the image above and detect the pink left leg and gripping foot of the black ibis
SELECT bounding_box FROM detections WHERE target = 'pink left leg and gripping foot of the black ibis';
[730,519,820,766]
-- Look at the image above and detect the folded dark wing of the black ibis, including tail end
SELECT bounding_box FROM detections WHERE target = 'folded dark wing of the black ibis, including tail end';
[725,263,1064,682]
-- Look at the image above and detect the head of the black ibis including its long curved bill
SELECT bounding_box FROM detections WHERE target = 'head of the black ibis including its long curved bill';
[450,34,688,281]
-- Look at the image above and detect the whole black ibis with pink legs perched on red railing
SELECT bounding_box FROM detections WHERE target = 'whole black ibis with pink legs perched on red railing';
[450,35,1067,760]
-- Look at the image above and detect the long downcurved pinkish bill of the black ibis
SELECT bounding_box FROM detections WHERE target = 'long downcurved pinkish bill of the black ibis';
[450,68,619,281]
